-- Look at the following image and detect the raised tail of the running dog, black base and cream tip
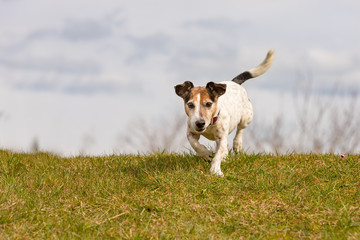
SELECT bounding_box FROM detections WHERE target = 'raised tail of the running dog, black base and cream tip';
[232,49,274,85]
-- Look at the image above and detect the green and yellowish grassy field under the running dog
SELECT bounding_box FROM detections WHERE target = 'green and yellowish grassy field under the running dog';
[0,151,360,239]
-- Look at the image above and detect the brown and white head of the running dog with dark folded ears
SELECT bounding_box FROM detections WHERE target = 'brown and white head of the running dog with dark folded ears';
[175,81,226,133]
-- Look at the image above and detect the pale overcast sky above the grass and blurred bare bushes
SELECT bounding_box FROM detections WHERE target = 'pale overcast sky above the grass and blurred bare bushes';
[0,0,360,155]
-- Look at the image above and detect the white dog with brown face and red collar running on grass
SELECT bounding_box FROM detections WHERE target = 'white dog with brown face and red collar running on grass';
[175,49,274,176]
